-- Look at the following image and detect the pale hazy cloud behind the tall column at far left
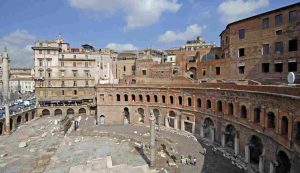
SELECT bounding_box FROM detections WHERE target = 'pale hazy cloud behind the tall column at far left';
[0,30,36,67]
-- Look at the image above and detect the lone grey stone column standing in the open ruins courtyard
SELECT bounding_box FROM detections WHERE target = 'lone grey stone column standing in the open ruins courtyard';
[149,115,156,167]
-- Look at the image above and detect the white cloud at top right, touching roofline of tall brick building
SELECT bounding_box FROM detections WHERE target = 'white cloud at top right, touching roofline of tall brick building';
[218,0,269,23]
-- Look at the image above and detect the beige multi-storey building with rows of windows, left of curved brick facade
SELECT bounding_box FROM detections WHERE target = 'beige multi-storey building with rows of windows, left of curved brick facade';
[32,36,116,114]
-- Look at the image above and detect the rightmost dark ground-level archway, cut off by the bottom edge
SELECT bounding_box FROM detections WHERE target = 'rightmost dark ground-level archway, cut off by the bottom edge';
[276,151,291,173]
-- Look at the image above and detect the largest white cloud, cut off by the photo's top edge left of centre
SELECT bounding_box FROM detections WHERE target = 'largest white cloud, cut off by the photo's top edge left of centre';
[69,0,181,29]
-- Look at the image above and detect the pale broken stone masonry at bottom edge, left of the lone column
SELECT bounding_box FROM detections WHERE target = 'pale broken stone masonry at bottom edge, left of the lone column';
[69,156,152,173]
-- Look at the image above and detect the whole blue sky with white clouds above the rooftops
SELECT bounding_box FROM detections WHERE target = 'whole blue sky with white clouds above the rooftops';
[0,0,298,67]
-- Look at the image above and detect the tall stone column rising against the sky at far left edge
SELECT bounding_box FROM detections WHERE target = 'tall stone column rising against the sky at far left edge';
[2,47,11,134]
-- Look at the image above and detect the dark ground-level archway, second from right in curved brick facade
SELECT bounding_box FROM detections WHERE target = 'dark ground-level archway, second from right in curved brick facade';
[249,135,264,164]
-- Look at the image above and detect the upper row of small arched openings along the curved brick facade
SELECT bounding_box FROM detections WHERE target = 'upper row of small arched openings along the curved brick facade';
[111,94,292,141]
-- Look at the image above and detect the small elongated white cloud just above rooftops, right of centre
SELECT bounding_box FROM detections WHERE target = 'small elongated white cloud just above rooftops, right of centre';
[158,24,206,43]
